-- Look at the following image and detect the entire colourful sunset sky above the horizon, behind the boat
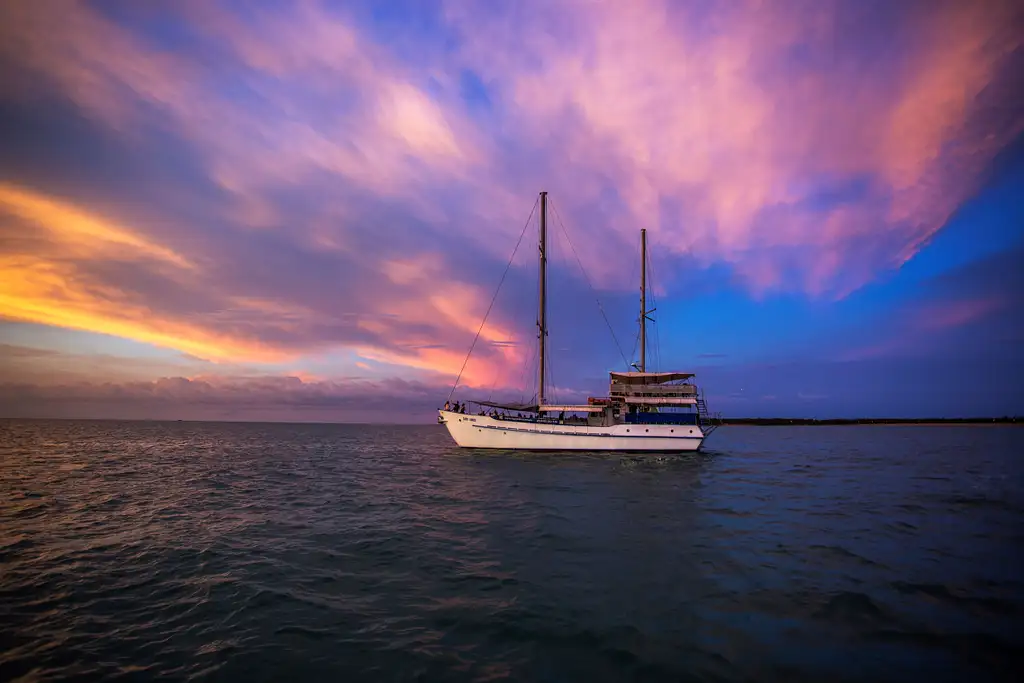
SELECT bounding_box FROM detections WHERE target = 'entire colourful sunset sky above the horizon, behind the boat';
[0,0,1024,422]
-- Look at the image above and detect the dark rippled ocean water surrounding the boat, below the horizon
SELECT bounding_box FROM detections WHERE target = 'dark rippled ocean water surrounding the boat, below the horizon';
[0,421,1024,682]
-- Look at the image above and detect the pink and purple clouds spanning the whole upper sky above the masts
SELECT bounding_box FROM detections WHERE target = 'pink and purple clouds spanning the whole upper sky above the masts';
[6,0,1024,294]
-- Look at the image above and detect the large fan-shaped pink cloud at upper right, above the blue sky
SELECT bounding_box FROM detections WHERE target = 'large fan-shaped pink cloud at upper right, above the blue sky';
[450,0,1024,294]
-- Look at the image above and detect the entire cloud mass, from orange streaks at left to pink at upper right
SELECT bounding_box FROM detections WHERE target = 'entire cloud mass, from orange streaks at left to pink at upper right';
[0,0,1024,419]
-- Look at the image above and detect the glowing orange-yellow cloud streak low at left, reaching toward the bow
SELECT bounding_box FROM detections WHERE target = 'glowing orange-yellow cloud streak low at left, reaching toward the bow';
[0,184,520,383]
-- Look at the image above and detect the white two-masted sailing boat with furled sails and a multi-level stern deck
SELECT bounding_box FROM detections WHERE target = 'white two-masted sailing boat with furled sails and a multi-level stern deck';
[437,191,715,453]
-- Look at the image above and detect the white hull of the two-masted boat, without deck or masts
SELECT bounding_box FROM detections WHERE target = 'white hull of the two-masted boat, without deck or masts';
[438,411,705,453]
